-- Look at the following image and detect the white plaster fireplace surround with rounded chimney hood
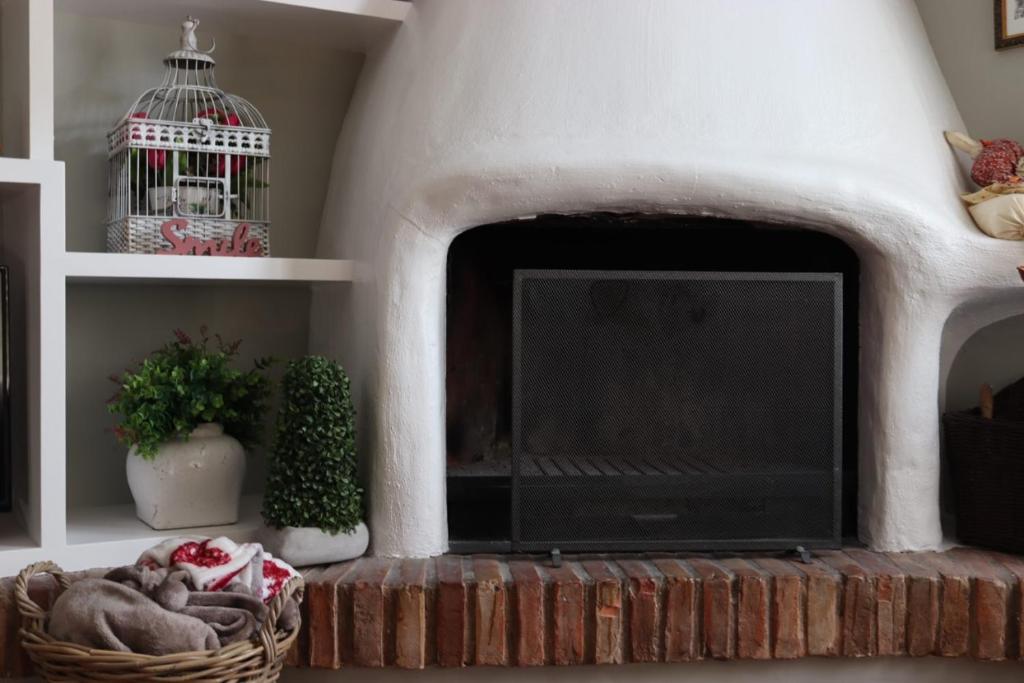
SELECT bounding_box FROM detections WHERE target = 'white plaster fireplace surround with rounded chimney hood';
[311,0,1024,556]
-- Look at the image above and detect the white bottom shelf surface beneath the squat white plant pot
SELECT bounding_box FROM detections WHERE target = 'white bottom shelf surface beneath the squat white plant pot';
[68,496,263,548]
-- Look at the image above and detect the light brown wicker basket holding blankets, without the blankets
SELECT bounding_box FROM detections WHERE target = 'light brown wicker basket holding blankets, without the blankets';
[14,562,303,683]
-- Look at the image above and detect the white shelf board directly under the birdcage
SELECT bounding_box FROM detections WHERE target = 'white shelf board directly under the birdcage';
[63,252,355,284]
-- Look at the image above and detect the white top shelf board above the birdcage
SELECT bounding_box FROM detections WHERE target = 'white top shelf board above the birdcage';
[56,0,411,52]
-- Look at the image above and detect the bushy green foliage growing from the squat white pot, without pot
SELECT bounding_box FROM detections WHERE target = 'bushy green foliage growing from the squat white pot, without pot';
[108,326,271,460]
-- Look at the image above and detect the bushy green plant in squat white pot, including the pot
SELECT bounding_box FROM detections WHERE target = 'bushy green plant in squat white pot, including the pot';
[108,327,270,529]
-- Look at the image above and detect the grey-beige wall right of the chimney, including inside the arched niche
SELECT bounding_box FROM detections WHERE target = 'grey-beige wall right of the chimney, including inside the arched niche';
[916,0,1024,410]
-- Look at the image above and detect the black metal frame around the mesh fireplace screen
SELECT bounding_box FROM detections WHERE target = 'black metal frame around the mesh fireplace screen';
[510,268,844,552]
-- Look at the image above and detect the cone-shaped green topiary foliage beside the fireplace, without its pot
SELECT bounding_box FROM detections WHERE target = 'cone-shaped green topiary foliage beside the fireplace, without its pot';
[263,356,362,533]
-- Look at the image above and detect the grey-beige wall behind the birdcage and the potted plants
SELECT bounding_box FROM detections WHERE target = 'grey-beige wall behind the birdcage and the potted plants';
[55,11,362,507]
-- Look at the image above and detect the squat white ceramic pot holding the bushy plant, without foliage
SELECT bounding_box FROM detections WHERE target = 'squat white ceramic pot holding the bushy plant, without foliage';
[126,424,246,529]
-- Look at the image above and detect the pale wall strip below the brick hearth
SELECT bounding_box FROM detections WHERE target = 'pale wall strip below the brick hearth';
[281,657,1022,683]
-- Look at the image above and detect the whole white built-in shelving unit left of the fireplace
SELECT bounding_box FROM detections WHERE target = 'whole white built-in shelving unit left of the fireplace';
[0,0,411,575]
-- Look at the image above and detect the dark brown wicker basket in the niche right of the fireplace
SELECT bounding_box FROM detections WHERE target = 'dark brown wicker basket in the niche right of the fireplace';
[942,409,1024,553]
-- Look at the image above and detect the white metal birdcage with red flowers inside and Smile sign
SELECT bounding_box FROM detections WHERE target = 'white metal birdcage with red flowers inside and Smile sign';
[106,16,270,256]
